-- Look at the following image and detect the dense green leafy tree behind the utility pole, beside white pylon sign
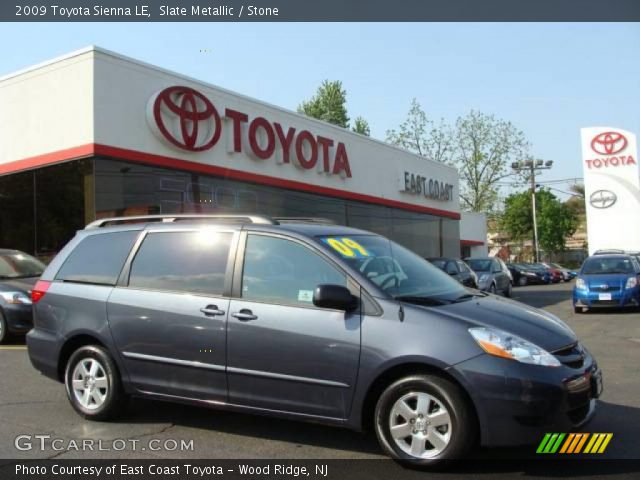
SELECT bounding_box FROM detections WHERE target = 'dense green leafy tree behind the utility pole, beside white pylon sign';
[500,189,578,253]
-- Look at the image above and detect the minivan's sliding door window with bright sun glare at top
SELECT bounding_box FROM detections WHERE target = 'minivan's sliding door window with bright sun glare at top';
[129,229,233,295]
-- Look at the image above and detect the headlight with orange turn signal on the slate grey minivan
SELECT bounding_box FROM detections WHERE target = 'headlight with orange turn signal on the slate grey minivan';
[469,327,561,367]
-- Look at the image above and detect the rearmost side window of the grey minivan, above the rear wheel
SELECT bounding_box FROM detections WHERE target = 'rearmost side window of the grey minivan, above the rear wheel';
[55,230,139,285]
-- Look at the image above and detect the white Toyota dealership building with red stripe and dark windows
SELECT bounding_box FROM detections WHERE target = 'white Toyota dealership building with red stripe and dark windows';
[0,47,486,257]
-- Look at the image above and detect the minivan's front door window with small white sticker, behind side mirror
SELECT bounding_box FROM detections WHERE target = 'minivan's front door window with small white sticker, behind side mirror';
[242,235,347,306]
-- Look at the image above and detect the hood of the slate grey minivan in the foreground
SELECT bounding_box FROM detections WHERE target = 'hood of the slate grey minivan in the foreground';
[430,295,578,352]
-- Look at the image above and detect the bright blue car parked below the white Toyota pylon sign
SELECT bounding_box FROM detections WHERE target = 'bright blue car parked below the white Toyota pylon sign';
[573,254,640,313]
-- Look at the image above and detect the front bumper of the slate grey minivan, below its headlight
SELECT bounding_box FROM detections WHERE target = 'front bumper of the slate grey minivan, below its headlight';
[452,350,602,446]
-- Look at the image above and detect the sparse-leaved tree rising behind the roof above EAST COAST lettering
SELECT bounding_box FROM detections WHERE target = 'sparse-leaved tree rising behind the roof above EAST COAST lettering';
[387,98,454,164]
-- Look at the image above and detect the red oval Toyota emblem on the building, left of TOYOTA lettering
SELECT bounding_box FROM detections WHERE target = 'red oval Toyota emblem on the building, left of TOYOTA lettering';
[153,86,222,152]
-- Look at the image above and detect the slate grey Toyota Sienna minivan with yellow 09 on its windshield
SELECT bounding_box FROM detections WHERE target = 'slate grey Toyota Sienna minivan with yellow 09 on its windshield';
[27,215,602,466]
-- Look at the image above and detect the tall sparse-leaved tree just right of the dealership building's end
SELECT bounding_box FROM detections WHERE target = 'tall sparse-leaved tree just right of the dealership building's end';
[454,110,529,213]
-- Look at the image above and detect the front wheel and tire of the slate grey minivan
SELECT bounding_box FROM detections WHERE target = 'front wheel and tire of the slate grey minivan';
[374,375,477,467]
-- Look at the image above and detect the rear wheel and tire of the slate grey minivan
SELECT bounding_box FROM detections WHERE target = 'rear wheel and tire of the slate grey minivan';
[64,345,126,421]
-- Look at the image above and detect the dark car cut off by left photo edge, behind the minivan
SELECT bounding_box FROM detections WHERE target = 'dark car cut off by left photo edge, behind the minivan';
[0,249,46,344]
